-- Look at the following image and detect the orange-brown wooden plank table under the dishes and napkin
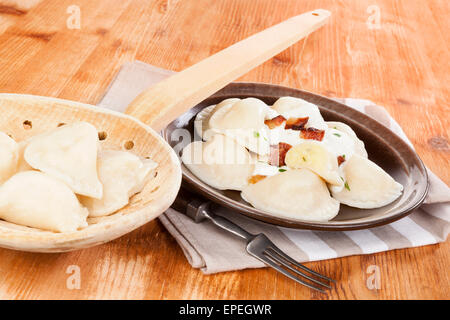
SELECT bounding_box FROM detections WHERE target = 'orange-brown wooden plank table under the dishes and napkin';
[0,0,450,299]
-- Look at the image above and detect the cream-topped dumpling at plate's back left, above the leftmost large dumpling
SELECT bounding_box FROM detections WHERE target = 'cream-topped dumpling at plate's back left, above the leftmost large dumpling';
[204,98,270,154]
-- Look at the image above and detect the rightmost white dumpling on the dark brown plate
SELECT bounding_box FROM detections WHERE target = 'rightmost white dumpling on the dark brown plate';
[331,154,403,209]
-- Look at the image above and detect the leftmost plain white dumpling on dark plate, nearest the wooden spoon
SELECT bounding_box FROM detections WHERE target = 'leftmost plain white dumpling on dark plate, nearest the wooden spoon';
[181,134,254,190]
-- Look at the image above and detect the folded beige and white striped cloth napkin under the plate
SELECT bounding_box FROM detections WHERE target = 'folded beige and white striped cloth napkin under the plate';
[99,61,450,274]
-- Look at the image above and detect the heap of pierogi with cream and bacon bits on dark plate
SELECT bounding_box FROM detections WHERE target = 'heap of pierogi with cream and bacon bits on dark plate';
[182,97,403,221]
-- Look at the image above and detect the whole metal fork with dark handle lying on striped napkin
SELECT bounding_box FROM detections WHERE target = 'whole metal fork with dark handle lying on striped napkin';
[174,191,335,293]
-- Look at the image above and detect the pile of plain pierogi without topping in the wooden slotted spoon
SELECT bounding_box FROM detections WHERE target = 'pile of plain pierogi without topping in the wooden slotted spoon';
[0,122,157,232]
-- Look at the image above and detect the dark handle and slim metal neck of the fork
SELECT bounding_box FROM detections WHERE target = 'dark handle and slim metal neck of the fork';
[173,189,255,241]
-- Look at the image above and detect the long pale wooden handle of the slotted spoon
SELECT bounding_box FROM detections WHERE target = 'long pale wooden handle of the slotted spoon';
[125,9,331,131]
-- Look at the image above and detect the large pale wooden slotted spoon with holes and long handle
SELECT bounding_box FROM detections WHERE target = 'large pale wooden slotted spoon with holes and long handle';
[0,10,330,252]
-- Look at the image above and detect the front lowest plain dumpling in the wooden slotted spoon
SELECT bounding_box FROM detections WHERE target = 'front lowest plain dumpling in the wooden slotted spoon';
[0,171,88,232]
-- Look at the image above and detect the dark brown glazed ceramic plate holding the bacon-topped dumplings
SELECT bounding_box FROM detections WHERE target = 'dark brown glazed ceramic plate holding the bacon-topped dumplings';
[163,83,428,230]
